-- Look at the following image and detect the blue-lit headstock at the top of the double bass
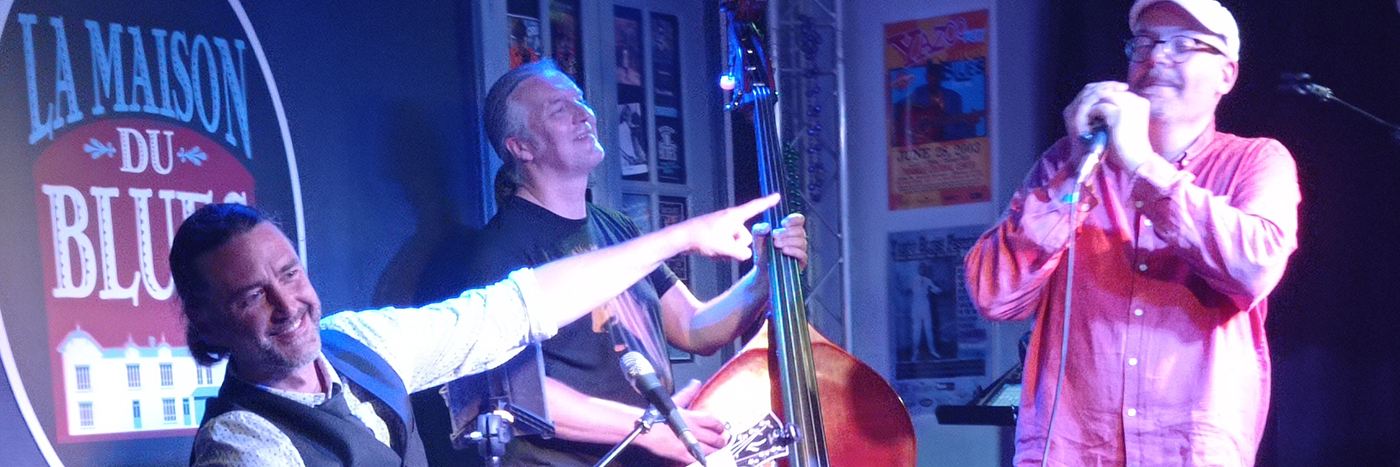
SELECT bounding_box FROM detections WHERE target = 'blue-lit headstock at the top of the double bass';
[720,0,773,110]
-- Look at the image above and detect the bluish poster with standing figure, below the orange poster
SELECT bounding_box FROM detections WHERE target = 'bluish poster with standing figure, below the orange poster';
[888,227,991,415]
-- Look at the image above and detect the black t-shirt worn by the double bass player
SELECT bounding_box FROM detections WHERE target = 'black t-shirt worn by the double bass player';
[420,197,676,466]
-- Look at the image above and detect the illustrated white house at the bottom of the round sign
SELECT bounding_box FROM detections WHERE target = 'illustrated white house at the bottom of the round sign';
[57,326,227,436]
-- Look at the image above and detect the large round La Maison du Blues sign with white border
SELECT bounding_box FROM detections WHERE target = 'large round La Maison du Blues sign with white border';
[0,0,305,466]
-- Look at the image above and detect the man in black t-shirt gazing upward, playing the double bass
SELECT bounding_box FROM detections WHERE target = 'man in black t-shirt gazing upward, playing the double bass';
[419,60,806,466]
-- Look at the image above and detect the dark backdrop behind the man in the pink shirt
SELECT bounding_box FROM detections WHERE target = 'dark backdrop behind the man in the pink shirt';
[1042,0,1400,466]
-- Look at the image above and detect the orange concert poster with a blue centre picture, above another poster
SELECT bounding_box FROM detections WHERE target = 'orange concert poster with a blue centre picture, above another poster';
[885,10,991,211]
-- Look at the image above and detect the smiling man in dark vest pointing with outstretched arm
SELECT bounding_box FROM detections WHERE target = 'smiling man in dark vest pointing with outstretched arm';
[169,196,777,467]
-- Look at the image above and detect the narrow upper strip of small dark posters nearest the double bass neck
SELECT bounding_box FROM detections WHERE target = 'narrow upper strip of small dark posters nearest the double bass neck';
[651,13,686,185]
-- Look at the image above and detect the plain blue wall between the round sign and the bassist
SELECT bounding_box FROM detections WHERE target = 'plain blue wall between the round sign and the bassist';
[245,0,483,312]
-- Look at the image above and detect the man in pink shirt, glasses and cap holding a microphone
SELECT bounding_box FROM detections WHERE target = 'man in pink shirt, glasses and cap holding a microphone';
[966,0,1301,466]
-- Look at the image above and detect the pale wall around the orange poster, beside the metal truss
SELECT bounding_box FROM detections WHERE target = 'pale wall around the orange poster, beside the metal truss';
[844,0,1058,467]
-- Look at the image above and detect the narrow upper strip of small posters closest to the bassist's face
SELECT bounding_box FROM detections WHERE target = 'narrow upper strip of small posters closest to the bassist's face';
[613,7,651,182]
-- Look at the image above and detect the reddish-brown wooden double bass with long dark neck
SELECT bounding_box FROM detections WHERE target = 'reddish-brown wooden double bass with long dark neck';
[690,0,917,467]
